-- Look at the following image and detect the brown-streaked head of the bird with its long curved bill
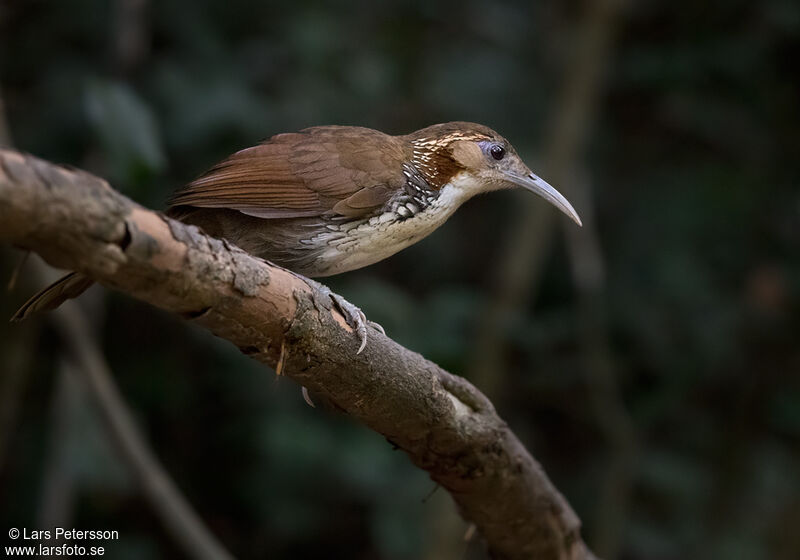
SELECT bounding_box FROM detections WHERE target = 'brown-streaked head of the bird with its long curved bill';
[408,122,582,226]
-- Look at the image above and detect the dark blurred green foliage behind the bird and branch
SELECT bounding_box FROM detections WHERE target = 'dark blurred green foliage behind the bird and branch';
[0,0,800,560]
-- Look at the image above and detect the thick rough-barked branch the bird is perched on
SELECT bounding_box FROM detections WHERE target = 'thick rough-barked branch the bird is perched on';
[0,150,593,560]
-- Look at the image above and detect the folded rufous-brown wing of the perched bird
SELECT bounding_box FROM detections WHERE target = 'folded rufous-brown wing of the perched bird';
[170,126,404,218]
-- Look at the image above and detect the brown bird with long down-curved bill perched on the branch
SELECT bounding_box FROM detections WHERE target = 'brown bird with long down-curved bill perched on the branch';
[12,122,582,352]
